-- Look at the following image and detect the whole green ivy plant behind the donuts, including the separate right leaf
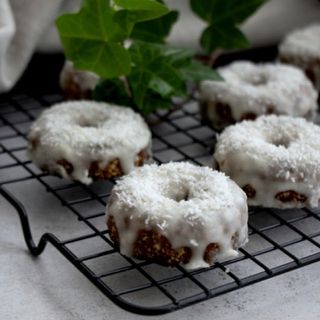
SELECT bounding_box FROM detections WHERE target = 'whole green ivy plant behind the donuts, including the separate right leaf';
[56,0,265,114]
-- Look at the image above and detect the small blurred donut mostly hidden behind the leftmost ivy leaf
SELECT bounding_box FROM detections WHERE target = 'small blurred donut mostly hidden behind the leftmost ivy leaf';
[60,60,99,99]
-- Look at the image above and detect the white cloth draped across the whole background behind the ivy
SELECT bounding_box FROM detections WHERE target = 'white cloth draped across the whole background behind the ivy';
[0,0,320,93]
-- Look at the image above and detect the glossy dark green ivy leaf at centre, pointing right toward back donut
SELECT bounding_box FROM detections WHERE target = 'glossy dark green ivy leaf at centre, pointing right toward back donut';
[128,41,221,114]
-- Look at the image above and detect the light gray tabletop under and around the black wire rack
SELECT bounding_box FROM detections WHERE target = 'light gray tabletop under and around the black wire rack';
[0,100,320,320]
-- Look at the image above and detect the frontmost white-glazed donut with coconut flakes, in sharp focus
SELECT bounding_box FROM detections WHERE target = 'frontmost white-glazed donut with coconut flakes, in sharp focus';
[106,162,248,269]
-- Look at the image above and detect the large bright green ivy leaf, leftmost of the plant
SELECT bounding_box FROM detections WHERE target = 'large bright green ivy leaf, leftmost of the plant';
[56,0,131,78]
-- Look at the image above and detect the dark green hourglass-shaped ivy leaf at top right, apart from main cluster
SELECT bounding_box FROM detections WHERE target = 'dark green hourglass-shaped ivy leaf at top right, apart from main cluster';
[190,0,267,53]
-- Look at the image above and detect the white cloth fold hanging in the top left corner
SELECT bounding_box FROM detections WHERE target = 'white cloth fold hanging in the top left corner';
[0,0,63,92]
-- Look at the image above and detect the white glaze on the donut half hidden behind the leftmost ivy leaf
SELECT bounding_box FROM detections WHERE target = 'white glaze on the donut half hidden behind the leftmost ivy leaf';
[60,60,99,93]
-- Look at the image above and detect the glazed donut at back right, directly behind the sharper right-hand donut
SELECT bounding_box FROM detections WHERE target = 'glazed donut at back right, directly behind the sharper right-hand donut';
[200,61,317,130]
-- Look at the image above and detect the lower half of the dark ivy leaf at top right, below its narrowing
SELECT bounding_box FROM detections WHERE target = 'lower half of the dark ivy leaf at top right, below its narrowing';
[200,26,250,52]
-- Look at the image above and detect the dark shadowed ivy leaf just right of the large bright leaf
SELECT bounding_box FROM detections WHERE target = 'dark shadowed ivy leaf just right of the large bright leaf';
[131,11,179,43]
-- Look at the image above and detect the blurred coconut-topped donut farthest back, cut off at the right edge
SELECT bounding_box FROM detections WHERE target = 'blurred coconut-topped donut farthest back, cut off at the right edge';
[279,24,320,91]
